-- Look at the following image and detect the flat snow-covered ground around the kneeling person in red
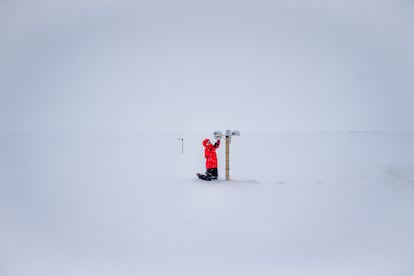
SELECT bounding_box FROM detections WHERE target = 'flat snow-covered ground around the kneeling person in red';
[0,133,414,276]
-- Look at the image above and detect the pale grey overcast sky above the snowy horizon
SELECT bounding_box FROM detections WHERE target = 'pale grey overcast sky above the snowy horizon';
[0,0,414,133]
